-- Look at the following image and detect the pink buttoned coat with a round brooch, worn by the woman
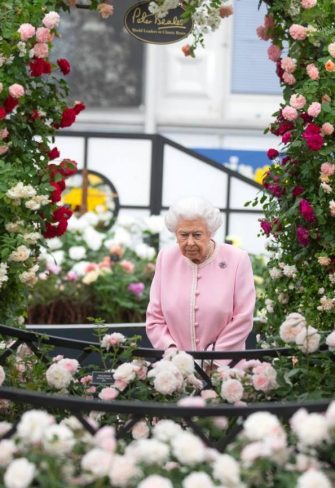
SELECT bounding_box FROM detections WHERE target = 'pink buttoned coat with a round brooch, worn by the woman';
[146,243,255,351]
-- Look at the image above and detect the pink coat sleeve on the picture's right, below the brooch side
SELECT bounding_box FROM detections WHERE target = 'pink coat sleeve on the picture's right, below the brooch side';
[215,253,256,351]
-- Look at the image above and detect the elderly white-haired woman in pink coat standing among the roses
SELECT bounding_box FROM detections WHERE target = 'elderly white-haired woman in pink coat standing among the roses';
[146,197,255,351]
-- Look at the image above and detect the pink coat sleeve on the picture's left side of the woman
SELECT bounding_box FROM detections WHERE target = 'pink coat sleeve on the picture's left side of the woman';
[146,252,175,349]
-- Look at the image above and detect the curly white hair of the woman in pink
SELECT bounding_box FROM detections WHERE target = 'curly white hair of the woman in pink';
[165,197,222,235]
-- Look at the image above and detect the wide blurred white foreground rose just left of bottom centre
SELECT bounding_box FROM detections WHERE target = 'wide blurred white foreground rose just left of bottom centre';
[125,439,169,465]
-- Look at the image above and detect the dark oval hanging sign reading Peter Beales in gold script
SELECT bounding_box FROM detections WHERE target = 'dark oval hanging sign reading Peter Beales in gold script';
[124,0,193,44]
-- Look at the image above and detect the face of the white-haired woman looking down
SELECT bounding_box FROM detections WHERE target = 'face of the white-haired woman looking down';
[176,219,211,263]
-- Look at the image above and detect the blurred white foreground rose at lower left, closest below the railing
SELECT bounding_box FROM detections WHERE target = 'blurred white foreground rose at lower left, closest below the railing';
[16,410,55,444]
